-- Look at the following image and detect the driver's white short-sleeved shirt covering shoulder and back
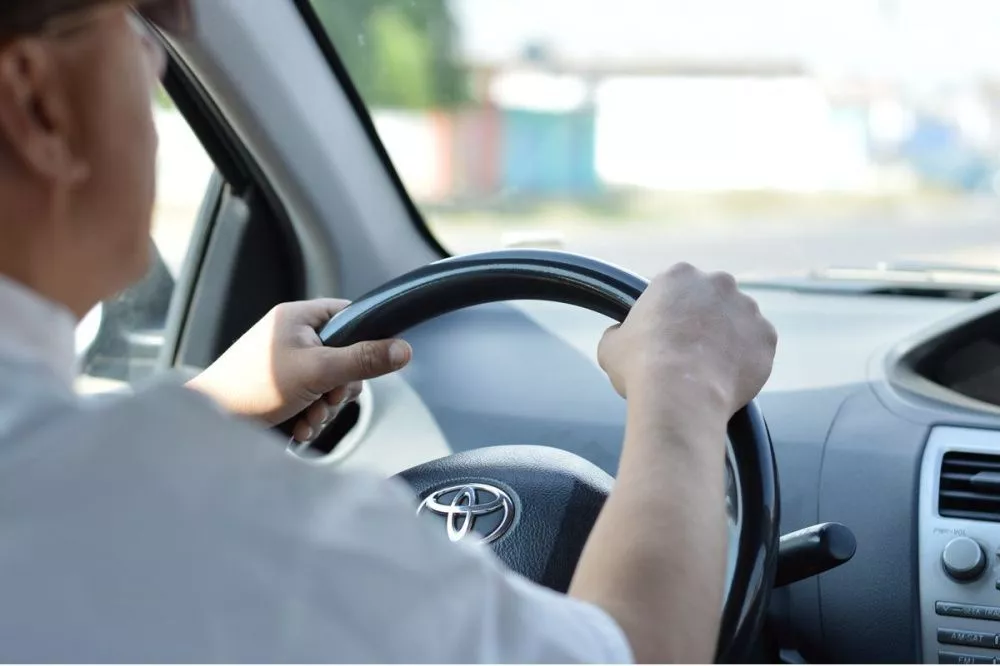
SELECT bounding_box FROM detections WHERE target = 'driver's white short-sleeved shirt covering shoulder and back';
[0,278,632,663]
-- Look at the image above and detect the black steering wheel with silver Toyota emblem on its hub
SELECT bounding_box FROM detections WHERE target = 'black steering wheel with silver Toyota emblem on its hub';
[312,250,778,662]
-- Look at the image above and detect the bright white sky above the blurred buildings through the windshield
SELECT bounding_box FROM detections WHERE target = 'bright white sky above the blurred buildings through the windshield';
[452,0,1000,82]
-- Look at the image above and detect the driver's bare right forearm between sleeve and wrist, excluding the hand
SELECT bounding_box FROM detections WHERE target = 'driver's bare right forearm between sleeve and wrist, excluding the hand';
[570,391,727,663]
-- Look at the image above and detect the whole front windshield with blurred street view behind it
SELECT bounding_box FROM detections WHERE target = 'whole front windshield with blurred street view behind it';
[313,0,1000,277]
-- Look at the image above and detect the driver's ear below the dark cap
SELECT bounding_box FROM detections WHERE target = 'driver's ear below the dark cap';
[0,38,88,185]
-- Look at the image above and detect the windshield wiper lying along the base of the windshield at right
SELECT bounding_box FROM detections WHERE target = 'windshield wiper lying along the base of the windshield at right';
[740,261,1000,301]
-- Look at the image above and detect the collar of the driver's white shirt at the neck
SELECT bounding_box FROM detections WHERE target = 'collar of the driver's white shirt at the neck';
[0,275,77,389]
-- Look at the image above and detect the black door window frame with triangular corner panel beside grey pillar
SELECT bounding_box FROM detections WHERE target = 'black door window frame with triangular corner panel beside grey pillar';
[80,33,305,390]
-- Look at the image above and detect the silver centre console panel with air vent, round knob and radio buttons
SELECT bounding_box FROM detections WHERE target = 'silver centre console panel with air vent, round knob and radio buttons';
[918,426,1000,664]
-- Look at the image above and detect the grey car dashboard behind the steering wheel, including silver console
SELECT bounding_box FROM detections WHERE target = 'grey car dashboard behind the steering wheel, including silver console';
[334,288,1000,663]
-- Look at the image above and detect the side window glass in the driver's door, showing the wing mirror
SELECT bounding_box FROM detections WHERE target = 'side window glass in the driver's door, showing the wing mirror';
[77,92,215,393]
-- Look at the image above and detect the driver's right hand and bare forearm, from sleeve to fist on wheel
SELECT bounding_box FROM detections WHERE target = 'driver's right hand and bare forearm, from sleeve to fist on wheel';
[569,264,777,663]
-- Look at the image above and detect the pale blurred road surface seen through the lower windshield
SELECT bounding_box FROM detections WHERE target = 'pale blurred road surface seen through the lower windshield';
[431,199,1000,276]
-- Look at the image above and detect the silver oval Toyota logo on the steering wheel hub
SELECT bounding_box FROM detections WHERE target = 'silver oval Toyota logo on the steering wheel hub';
[417,483,514,543]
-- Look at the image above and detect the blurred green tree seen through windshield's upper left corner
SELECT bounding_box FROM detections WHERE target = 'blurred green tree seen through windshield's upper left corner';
[312,0,467,108]
